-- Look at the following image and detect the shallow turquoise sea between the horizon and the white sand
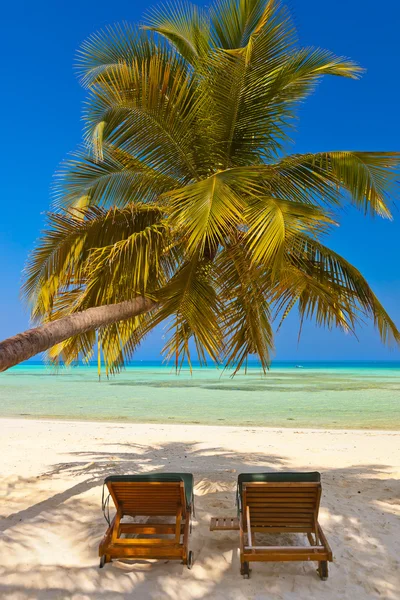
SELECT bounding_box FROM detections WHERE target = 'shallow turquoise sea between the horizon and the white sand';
[0,362,400,430]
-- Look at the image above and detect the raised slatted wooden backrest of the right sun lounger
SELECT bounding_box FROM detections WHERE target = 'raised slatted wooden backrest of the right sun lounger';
[242,482,321,531]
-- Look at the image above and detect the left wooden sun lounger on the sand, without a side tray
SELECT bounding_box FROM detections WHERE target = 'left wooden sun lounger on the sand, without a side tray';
[99,473,193,569]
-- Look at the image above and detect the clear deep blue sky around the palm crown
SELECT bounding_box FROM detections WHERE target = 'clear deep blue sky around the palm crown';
[0,0,400,360]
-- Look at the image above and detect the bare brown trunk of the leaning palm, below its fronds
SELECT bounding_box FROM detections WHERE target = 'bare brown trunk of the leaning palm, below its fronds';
[0,297,157,371]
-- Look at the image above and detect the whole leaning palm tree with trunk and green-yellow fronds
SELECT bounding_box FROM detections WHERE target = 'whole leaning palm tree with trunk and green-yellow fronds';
[0,0,400,371]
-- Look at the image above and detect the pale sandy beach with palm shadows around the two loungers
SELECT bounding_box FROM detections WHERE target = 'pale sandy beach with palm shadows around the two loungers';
[0,419,400,600]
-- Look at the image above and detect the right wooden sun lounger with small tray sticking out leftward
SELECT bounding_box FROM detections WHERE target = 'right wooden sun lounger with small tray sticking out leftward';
[210,473,332,580]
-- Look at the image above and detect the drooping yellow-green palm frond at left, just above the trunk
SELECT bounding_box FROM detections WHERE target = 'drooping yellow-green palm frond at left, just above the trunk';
[23,205,169,319]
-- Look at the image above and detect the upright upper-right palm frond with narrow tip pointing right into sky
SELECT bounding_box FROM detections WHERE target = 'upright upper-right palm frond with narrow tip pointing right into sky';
[199,11,361,168]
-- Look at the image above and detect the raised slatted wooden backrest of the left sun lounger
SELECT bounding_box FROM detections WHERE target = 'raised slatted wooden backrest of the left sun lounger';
[106,481,186,516]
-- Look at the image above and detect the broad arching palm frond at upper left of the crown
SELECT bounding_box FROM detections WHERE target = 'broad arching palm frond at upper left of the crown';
[85,51,201,180]
